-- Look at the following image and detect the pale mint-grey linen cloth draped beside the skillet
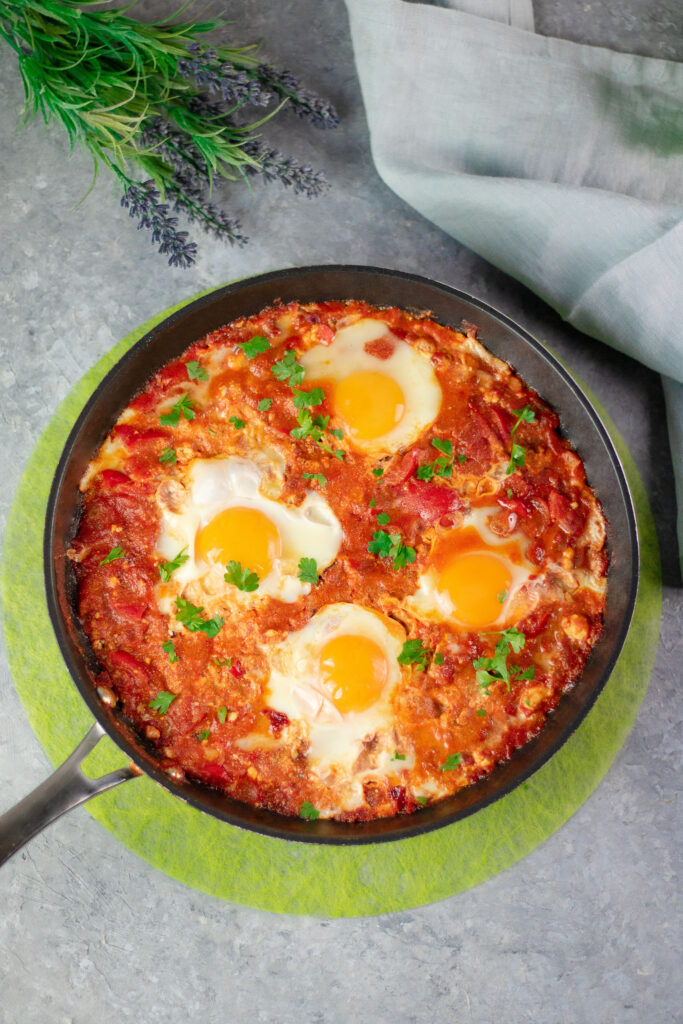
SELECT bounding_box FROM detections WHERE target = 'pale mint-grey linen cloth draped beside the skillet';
[346,0,683,569]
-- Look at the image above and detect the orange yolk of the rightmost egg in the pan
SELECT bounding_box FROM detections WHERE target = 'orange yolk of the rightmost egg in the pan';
[438,551,512,627]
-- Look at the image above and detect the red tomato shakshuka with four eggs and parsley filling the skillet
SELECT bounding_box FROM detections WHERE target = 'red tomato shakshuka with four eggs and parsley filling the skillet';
[69,301,607,821]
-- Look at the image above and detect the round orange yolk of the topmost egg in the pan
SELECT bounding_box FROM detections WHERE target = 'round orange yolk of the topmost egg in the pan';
[334,370,405,440]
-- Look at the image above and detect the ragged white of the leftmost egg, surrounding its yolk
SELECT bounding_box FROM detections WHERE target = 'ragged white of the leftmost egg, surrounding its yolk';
[157,458,342,614]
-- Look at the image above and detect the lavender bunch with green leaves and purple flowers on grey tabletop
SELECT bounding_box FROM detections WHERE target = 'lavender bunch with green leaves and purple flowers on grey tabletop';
[0,0,338,266]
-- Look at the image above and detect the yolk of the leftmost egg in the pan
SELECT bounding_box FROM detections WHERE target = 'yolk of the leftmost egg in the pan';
[195,508,282,580]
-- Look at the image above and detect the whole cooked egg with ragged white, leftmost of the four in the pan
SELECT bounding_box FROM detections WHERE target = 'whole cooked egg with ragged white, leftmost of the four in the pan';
[157,458,342,613]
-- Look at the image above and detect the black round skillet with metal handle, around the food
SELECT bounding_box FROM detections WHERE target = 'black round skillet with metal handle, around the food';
[0,265,638,862]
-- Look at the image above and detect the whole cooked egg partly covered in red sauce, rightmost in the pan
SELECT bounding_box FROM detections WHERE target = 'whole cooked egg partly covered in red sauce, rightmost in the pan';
[409,507,539,630]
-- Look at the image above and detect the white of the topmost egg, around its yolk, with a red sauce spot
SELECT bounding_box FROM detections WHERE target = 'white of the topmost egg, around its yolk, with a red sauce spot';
[300,318,441,456]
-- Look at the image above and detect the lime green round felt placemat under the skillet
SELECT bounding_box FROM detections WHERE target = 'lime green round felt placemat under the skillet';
[0,290,661,918]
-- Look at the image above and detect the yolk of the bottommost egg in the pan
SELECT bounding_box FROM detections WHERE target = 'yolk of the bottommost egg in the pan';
[318,635,389,714]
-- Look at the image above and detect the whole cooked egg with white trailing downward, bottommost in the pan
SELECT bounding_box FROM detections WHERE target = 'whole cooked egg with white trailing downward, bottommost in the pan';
[265,603,413,810]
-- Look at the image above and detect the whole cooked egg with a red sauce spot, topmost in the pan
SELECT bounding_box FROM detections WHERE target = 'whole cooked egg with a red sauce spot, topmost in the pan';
[301,318,441,456]
